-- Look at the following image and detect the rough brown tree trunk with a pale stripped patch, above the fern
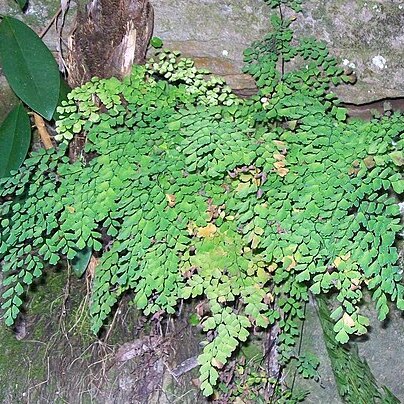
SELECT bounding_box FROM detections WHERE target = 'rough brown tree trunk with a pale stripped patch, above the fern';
[66,0,154,161]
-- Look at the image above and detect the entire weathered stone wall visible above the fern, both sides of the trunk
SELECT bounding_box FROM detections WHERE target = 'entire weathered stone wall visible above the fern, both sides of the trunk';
[0,0,404,118]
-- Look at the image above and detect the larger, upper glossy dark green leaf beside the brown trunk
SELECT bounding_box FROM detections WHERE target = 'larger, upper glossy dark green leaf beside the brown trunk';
[0,17,60,120]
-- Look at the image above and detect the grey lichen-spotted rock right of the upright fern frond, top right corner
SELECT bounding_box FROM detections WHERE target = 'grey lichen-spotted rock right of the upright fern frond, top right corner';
[295,0,404,104]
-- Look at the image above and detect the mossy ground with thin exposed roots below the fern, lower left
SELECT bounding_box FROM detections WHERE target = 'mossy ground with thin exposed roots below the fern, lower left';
[0,272,204,404]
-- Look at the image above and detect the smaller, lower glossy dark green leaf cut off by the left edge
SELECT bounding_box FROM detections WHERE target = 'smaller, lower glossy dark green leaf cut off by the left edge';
[0,104,31,178]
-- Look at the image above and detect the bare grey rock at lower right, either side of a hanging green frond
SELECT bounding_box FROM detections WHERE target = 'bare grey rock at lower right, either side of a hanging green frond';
[295,299,404,404]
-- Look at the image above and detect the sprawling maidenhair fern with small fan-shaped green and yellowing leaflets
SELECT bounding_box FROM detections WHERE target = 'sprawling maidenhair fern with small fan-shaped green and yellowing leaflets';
[0,1,404,395]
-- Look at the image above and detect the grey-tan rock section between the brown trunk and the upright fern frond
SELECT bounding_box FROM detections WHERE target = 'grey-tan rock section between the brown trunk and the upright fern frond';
[148,0,270,92]
